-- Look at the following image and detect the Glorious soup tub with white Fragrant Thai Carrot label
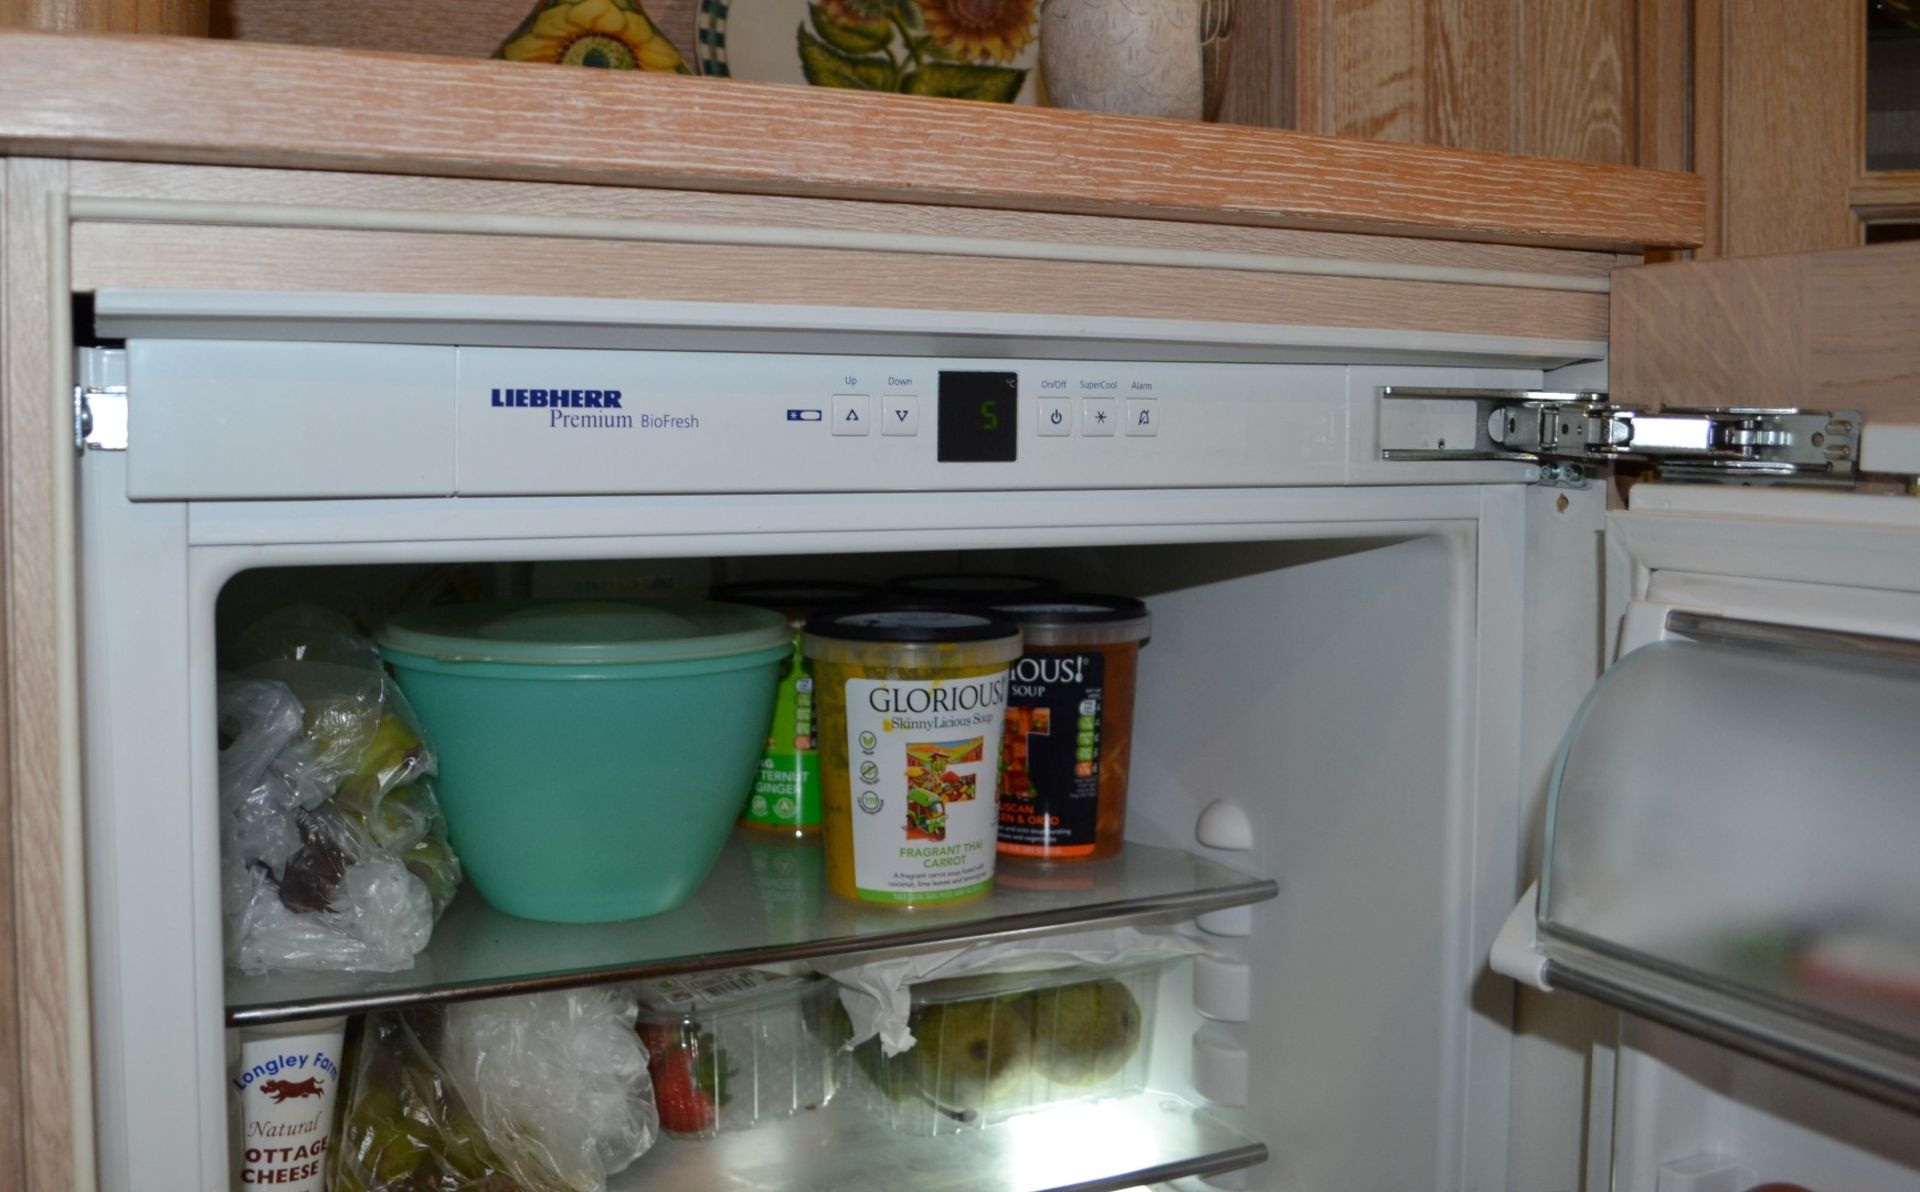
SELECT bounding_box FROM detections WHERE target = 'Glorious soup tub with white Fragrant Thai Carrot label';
[803,605,1020,908]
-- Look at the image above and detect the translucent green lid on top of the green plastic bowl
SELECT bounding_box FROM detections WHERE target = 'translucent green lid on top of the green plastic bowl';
[380,601,793,666]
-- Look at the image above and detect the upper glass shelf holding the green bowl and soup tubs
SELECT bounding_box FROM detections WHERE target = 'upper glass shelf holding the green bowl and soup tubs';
[227,833,1279,1025]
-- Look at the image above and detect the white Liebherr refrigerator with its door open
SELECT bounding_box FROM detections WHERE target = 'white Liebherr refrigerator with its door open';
[75,290,1920,1192]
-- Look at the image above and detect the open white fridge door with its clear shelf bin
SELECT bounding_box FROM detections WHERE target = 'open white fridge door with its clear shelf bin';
[1494,486,1920,1192]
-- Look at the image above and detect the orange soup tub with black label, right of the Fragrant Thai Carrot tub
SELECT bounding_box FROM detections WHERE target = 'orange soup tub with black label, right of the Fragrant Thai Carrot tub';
[995,593,1152,860]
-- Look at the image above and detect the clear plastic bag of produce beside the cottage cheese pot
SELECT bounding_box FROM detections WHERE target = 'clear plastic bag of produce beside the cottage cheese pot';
[334,989,659,1192]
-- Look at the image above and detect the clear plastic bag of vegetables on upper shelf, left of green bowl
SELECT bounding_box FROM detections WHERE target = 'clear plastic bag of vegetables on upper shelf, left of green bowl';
[219,610,461,971]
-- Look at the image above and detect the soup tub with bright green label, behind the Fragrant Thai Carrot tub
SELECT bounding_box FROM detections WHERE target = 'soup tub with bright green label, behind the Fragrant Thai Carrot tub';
[708,580,879,837]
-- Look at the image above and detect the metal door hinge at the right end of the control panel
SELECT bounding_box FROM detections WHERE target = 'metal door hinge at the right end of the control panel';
[1380,386,1860,484]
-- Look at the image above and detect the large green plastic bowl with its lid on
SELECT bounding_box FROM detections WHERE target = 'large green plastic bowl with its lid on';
[380,601,793,923]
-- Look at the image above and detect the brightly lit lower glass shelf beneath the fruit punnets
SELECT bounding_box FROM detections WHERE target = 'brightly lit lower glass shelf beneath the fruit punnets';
[611,1092,1267,1192]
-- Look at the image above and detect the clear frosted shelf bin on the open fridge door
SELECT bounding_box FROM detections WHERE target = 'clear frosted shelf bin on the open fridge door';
[1494,610,1920,1109]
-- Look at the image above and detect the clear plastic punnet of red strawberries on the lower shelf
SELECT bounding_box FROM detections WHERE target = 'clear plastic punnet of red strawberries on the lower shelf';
[634,969,839,1138]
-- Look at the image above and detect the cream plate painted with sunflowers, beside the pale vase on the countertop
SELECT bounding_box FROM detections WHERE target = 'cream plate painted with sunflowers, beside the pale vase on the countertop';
[693,0,1041,104]
